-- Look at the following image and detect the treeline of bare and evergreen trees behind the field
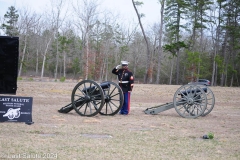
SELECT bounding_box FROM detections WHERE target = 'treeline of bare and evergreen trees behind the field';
[0,0,240,86]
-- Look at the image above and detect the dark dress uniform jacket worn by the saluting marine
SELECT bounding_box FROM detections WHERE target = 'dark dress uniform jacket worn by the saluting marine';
[112,68,134,93]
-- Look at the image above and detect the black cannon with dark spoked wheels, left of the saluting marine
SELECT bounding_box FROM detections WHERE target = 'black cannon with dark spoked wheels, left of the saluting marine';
[58,80,123,117]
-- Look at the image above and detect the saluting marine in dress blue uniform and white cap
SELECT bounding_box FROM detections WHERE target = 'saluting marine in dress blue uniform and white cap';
[112,61,134,115]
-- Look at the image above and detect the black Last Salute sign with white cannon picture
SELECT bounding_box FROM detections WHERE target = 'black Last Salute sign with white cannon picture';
[0,96,33,124]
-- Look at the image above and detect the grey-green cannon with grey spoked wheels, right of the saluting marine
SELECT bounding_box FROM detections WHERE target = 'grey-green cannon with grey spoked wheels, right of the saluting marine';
[144,84,215,118]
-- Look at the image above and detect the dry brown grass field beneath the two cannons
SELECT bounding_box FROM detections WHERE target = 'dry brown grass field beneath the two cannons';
[0,81,240,160]
